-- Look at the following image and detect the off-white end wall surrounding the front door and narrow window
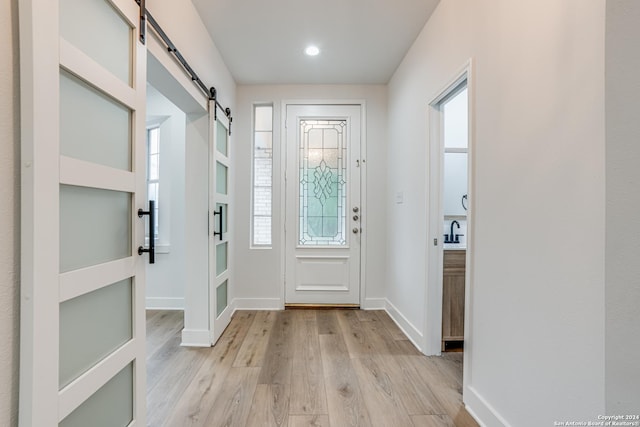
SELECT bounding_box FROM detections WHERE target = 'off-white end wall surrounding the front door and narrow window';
[232,85,387,308]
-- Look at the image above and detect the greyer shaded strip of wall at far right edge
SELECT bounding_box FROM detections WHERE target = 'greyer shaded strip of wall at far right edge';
[605,0,640,414]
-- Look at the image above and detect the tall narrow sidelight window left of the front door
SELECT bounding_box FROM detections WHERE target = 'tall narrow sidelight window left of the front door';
[251,105,273,247]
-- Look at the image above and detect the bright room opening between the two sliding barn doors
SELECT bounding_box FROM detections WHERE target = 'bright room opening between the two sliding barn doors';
[145,52,211,346]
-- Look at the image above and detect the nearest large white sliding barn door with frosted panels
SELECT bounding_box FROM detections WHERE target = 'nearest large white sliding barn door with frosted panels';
[19,0,149,426]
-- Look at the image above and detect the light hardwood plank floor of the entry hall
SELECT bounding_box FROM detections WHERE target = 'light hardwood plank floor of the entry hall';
[147,310,477,427]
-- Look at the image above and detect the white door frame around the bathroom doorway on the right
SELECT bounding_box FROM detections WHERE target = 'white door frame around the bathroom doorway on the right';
[423,59,476,390]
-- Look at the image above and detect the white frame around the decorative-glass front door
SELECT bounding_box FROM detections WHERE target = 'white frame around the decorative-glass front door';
[274,99,368,309]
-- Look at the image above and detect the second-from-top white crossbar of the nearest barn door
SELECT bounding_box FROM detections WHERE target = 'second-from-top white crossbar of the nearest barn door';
[60,156,136,193]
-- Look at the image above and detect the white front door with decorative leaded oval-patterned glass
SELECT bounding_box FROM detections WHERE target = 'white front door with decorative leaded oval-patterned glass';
[285,105,362,305]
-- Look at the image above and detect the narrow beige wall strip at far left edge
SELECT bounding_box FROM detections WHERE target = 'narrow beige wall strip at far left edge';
[0,0,20,426]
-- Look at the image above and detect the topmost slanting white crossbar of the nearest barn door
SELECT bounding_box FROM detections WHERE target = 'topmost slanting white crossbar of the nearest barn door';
[60,37,136,110]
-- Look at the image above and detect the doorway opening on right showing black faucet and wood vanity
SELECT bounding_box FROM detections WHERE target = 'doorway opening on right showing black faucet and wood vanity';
[425,63,473,364]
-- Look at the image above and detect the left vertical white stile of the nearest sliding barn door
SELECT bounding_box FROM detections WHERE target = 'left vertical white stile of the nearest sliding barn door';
[18,0,60,427]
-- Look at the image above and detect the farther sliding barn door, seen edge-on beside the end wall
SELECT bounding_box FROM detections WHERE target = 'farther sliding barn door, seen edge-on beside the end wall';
[209,101,233,344]
